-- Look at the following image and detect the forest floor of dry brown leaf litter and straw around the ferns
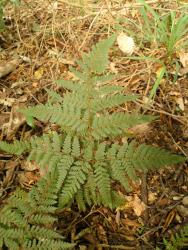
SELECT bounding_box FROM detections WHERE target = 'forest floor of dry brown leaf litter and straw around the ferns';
[0,0,188,250]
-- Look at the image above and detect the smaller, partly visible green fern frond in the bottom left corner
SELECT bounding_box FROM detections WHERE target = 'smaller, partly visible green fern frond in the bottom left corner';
[0,168,74,250]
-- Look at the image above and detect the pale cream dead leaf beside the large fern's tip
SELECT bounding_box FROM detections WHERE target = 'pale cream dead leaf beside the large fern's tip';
[117,32,135,56]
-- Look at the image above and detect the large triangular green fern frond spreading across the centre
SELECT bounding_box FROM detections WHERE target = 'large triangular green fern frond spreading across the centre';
[0,35,184,210]
